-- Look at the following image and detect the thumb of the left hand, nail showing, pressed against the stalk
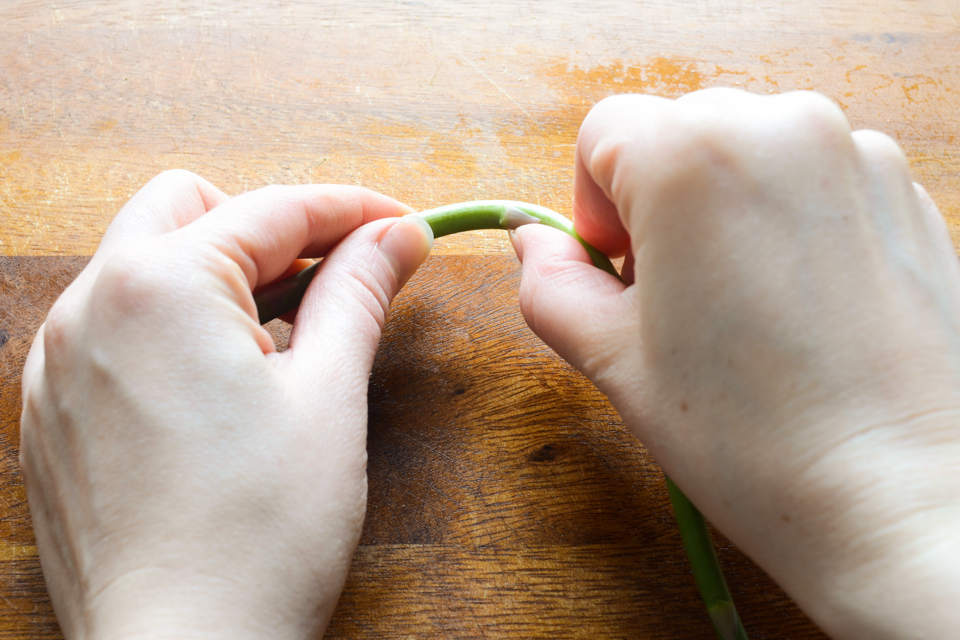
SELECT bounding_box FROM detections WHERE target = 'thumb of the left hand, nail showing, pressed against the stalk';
[284,216,433,384]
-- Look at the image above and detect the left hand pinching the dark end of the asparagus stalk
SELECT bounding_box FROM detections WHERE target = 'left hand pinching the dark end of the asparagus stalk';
[20,172,433,639]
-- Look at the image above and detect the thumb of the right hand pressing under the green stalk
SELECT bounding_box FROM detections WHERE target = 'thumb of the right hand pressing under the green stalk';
[506,225,635,385]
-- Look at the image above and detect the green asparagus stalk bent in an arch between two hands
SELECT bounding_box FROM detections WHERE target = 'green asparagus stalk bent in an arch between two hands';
[254,200,747,640]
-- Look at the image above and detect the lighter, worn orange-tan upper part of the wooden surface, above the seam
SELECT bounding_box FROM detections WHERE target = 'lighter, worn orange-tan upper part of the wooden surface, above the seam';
[0,0,960,255]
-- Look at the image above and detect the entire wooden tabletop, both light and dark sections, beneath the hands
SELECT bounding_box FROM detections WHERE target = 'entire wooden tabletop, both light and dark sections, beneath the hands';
[0,0,960,640]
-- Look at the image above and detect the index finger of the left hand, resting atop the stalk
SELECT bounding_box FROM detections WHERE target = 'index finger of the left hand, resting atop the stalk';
[182,185,413,290]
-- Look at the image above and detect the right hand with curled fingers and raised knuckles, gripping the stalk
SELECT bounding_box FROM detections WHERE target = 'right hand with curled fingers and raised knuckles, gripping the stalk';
[515,90,960,639]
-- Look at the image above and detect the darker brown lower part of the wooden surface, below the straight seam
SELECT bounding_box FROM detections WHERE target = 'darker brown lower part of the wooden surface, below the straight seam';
[0,256,823,640]
